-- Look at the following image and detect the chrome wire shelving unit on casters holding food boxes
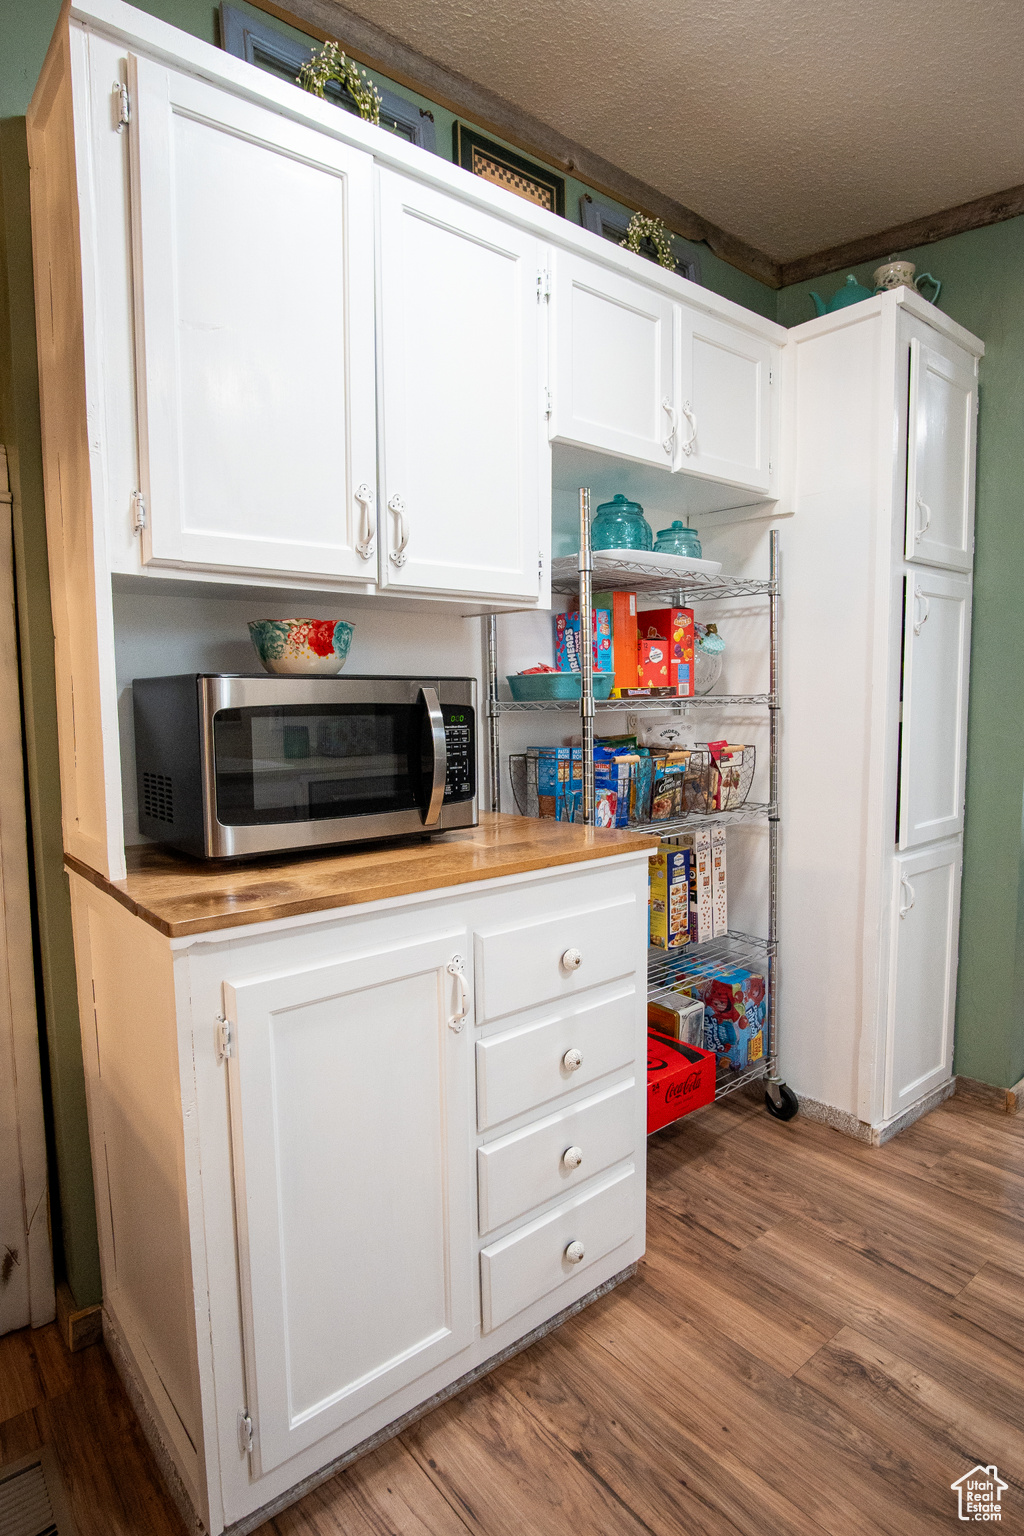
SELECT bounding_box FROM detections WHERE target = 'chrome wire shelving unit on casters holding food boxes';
[487,490,798,1120]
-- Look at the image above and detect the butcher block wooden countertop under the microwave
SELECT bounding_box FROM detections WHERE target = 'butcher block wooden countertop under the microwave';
[64,814,659,938]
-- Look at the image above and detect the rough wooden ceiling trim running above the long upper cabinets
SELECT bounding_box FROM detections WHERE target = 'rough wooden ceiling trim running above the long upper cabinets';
[251,0,781,289]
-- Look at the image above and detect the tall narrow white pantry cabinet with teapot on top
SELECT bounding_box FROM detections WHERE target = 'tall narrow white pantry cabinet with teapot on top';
[780,289,984,1140]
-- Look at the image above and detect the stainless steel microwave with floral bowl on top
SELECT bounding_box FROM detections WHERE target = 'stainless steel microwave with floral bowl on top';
[132,673,477,859]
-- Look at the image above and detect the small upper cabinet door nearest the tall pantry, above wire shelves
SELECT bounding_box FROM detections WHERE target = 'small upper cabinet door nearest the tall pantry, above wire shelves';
[676,307,774,493]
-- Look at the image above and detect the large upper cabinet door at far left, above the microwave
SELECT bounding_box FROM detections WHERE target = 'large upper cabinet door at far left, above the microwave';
[124,58,376,582]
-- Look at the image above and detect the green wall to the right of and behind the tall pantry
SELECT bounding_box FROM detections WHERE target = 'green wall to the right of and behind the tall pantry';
[777,227,1024,1087]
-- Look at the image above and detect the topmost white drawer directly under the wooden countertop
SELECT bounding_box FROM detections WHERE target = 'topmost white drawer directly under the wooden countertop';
[474,894,635,1025]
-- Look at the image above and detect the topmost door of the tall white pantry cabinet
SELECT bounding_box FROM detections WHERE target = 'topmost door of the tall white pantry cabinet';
[906,336,978,571]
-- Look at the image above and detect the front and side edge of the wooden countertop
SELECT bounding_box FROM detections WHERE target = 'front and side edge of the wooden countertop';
[64,833,659,938]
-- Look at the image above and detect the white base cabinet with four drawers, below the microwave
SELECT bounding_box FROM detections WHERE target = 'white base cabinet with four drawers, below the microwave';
[72,851,646,1536]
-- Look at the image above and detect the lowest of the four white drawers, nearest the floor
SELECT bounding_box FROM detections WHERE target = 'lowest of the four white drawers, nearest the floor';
[481,1163,637,1333]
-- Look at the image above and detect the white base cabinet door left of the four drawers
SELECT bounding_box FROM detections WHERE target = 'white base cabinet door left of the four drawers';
[224,929,476,1473]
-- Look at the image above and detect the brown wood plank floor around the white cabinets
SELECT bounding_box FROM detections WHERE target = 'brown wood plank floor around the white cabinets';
[0,1098,1024,1536]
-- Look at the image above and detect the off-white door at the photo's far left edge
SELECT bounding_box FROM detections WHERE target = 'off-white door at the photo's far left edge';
[0,473,54,1333]
